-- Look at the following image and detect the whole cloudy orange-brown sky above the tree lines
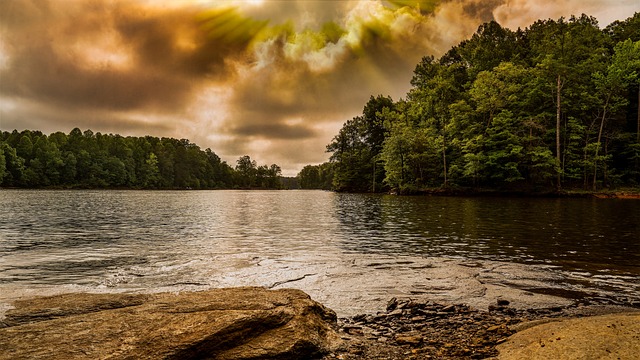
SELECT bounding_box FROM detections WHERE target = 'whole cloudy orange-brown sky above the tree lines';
[0,0,640,176]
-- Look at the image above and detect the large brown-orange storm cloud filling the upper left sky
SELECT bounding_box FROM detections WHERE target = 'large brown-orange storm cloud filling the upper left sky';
[0,0,246,110]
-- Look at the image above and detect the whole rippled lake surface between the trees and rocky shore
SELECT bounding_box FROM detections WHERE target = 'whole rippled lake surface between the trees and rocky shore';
[0,190,640,312]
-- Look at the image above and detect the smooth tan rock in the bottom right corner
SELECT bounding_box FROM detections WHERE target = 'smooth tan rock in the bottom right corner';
[498,312,640,360]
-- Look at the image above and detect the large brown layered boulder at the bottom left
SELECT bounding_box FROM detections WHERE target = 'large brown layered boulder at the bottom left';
[0,288,340,360]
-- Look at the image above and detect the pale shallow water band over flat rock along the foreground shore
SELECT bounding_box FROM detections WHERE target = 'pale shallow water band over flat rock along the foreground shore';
[0,254,640,318]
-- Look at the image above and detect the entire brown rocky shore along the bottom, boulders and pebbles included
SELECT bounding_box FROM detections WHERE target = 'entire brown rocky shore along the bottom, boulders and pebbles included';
[0,287,640,360]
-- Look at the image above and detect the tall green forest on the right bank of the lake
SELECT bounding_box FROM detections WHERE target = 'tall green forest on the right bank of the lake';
[298,13,640,193]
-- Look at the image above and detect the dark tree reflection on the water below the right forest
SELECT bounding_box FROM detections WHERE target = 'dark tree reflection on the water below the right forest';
[335,194,640,274]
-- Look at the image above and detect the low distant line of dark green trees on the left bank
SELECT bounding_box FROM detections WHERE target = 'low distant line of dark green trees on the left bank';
[0,128,281,189]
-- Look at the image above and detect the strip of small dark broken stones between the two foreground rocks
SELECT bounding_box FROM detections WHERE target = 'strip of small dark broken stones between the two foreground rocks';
[325,298,640,360]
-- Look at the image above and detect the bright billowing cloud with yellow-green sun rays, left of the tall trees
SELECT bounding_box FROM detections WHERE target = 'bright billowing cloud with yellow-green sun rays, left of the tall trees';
[224,2,444,132]
